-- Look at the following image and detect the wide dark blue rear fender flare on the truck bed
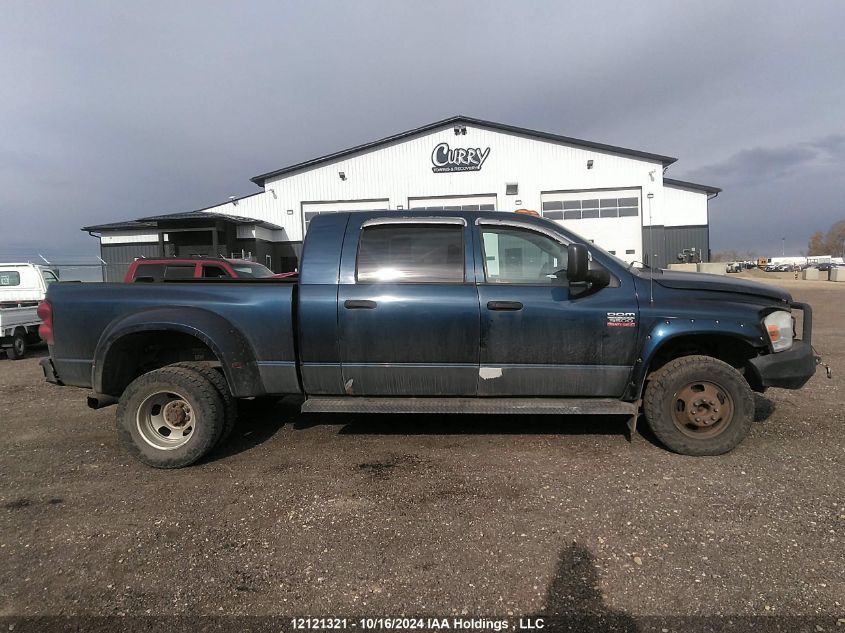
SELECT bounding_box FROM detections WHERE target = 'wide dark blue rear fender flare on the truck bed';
[91,307,264,397]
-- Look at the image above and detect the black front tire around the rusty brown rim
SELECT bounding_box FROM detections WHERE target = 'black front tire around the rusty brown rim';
[643,356,754,456]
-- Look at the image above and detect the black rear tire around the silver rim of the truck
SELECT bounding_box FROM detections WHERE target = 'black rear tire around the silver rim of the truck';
[116,367,226,468]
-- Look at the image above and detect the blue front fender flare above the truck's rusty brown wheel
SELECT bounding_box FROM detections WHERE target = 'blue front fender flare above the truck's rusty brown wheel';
[625,318,766,400]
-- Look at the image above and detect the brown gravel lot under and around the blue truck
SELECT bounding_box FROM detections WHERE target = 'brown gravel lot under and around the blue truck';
[0,277,845,631]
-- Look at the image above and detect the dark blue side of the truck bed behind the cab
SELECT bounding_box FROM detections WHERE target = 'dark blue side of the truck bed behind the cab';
[50,279,299,397]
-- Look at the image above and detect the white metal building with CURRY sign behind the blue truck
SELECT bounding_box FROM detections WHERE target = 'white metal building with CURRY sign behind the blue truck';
[85,116,720,278]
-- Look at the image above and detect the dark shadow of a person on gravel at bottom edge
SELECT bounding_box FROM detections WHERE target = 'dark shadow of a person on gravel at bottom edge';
[526,542,639,633]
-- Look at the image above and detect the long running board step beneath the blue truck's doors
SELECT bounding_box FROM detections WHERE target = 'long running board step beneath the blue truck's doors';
[302,396,639,416]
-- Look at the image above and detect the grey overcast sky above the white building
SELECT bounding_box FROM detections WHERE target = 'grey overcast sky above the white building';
[0,0,845,260]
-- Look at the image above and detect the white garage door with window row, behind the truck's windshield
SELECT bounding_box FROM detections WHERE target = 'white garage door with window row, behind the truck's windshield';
[540,189,642,261]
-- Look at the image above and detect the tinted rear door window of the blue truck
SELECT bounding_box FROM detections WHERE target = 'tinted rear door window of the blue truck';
[356,224,464,283]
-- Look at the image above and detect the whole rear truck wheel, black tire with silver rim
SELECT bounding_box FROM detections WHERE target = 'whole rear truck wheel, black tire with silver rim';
[117,367,225,468]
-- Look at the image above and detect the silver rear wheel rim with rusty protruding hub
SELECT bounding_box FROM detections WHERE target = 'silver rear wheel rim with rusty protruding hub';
[136,391,199,451]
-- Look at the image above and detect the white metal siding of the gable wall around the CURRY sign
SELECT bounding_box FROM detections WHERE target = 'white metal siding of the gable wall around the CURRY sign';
[208,125,663,241]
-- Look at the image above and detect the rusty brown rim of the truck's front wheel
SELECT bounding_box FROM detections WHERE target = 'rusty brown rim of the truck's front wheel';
[672,380,734,439]
